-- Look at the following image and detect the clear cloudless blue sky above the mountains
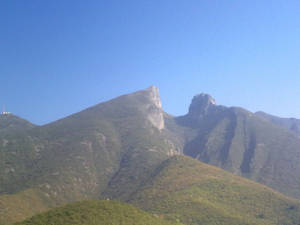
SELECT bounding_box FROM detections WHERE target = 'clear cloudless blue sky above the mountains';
[0,0,300,124]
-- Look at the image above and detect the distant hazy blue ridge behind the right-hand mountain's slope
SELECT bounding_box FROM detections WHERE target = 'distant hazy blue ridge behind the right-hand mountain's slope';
[255,111,300,134]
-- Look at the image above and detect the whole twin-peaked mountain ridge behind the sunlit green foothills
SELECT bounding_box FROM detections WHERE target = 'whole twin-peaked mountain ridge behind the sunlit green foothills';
[0,87,300,225]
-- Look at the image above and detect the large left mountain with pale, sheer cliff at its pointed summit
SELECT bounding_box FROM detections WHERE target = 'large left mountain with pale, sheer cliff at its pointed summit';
[0,87,180,222]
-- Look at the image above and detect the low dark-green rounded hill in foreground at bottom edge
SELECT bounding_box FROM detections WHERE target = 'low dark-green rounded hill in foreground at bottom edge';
[15,201,179,225]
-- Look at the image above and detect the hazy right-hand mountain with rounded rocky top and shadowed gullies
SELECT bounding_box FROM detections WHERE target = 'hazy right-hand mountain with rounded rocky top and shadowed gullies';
[174,94,300,198]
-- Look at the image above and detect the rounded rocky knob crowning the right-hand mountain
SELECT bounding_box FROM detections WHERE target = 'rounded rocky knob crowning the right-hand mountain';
[189,93,216,115]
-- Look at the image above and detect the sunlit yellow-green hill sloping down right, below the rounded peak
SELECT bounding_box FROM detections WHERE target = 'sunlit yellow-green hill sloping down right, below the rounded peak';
[129,156,300,225]
